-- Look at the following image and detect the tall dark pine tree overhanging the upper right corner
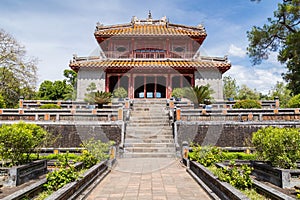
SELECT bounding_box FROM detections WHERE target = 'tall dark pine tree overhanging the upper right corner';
[247,0,300,95]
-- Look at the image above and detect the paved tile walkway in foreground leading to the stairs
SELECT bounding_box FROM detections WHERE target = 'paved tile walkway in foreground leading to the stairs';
[87,158,210,200]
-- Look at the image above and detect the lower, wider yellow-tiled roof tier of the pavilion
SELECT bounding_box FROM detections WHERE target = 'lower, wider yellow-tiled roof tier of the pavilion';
[70,60,231,73]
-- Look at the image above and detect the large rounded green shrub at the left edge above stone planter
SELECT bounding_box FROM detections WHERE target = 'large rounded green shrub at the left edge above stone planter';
[0,122,47,165]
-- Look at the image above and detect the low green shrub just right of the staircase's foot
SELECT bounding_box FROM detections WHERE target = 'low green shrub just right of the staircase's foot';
[189,145,223,167]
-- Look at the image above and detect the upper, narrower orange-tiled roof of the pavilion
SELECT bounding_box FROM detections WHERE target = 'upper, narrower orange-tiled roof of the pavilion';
[95,24,206,37]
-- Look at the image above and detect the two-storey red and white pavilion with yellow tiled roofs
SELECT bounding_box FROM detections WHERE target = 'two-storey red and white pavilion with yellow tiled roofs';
[70,12,231,100]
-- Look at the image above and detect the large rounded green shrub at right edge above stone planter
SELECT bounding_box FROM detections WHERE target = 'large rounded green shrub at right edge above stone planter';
[252,126,300,169]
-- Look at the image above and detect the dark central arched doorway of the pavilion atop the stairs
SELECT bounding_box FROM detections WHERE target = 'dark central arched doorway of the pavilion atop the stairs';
[134,76,166,98]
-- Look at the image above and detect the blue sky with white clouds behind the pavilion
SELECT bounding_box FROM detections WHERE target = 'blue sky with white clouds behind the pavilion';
[0,0,286,94]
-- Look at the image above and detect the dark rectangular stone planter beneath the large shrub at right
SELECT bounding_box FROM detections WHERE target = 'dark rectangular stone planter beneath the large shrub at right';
[251,161,300,188]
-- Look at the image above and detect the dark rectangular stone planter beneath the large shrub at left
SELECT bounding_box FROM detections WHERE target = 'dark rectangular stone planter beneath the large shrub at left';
[0,160,47,187]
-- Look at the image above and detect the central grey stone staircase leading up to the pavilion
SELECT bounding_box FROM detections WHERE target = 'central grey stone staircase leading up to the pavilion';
[123,100,176,158]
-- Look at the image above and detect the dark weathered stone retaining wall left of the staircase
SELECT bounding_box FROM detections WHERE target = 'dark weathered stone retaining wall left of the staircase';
[40,124,122,148]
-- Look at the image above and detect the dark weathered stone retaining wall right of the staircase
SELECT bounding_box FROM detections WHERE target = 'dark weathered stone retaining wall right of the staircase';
[175,122,300,147]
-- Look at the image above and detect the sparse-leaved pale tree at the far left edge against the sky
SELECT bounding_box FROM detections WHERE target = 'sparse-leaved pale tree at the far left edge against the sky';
[0,29,37,107]
